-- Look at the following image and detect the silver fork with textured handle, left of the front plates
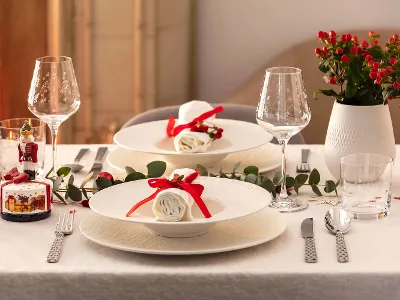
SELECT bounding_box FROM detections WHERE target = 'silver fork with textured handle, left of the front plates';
[47,210,75,263]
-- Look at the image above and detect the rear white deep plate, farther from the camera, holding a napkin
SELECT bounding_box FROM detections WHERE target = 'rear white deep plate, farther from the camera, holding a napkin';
[114,119,272,167]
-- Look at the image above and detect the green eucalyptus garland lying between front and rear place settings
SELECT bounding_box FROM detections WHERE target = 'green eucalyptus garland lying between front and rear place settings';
[46,161,339,206]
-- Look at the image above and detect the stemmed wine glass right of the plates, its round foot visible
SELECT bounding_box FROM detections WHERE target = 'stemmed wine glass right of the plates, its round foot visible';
[256,67,311,212]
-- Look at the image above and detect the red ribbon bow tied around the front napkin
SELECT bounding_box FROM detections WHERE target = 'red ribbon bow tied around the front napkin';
[126,172,211,218]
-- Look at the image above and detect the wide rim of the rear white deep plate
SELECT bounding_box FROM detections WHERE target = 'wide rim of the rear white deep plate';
[113,119,273,157]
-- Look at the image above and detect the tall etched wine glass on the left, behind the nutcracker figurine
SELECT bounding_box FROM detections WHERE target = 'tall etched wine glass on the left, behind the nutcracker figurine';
[28,56,80,177]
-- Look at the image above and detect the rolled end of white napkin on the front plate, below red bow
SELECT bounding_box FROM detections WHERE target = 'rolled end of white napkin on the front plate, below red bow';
[153,188,194,222]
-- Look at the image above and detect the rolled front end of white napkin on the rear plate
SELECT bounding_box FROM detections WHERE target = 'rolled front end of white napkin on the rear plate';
[174,129,212,153]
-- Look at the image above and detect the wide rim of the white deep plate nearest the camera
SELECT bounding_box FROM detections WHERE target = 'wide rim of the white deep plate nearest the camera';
[89,177,272,227]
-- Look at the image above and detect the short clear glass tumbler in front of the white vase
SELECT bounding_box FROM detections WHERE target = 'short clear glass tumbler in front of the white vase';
[340,153,393,220]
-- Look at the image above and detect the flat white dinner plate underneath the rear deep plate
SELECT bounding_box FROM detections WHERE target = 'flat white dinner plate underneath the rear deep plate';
[107,143,281,175]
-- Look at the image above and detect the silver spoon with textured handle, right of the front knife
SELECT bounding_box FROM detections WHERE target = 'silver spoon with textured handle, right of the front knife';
[325,207,351,263]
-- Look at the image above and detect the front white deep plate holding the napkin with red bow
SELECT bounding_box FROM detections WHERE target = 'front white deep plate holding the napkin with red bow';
[89,177,271,237]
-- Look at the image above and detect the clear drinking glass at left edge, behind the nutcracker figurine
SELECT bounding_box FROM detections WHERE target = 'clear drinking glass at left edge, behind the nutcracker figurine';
[0,118,46,178]
